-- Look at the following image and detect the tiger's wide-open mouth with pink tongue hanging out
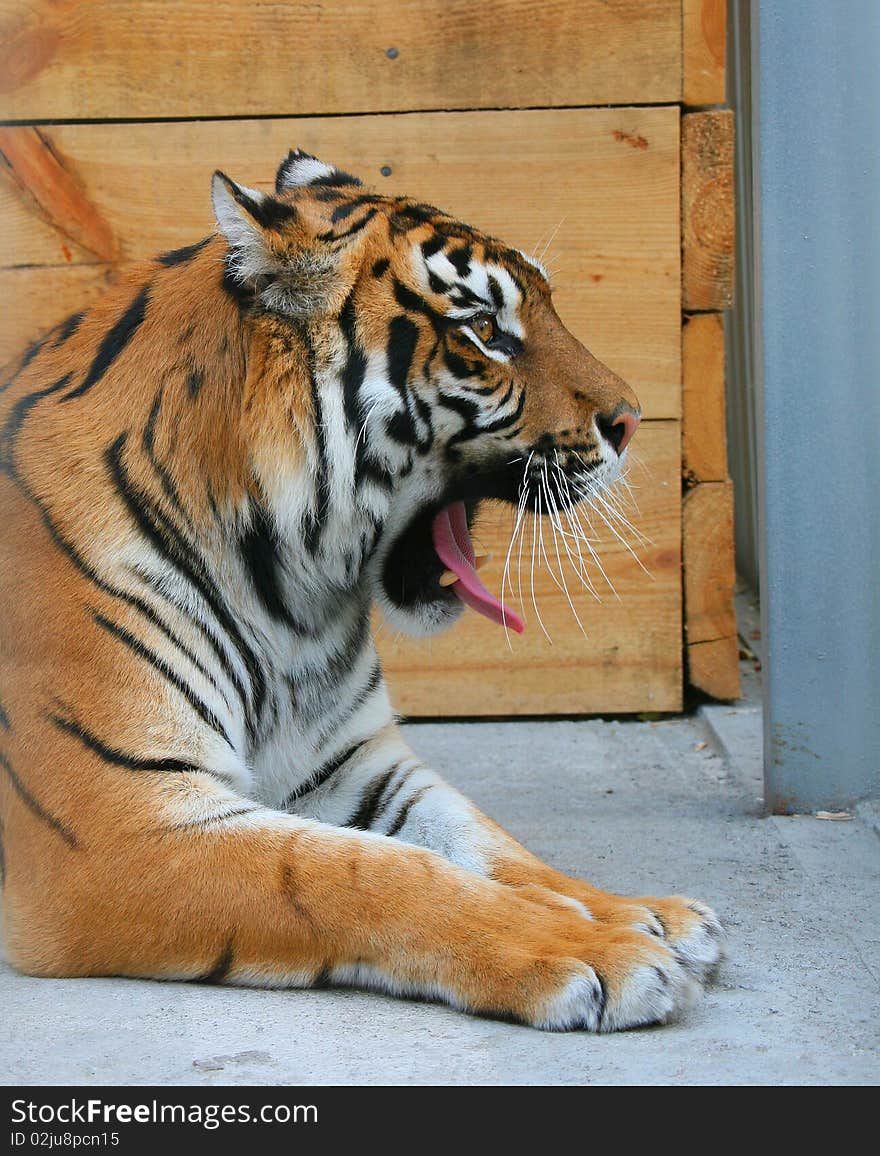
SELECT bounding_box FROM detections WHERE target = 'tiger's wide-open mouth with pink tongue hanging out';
[382,460,525,633]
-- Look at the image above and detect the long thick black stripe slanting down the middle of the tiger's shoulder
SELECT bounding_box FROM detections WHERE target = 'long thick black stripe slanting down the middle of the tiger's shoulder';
[105,434,266,733]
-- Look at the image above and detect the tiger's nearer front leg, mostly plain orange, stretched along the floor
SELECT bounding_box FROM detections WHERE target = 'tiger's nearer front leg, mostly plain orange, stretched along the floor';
[6,776,687,1030]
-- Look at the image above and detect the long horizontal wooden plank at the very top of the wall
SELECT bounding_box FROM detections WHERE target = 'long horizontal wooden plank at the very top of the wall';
[0,0,681,120]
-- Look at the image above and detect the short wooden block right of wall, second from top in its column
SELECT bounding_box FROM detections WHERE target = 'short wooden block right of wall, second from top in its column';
[681,109,734,310]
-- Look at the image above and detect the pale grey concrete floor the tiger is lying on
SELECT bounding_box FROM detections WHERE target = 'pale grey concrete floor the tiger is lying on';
[0,656,880,1087]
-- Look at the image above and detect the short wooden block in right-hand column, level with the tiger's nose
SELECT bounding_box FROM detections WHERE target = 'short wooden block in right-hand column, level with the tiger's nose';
[681,313,727,483]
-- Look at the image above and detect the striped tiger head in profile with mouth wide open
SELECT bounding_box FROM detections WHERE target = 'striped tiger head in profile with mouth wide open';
[213,150,639,633]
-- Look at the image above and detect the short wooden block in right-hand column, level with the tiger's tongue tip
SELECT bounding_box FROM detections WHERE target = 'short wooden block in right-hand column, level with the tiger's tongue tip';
[682,473,737,645]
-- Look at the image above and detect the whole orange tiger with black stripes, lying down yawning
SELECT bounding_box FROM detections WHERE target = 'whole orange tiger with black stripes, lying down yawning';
[0,150,723,1031]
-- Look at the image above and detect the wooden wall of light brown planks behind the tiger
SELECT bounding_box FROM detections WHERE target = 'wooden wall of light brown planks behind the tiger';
[0,0,737,714]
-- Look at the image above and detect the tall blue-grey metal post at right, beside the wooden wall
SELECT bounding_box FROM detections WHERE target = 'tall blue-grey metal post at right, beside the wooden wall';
[753,0,880,813]
